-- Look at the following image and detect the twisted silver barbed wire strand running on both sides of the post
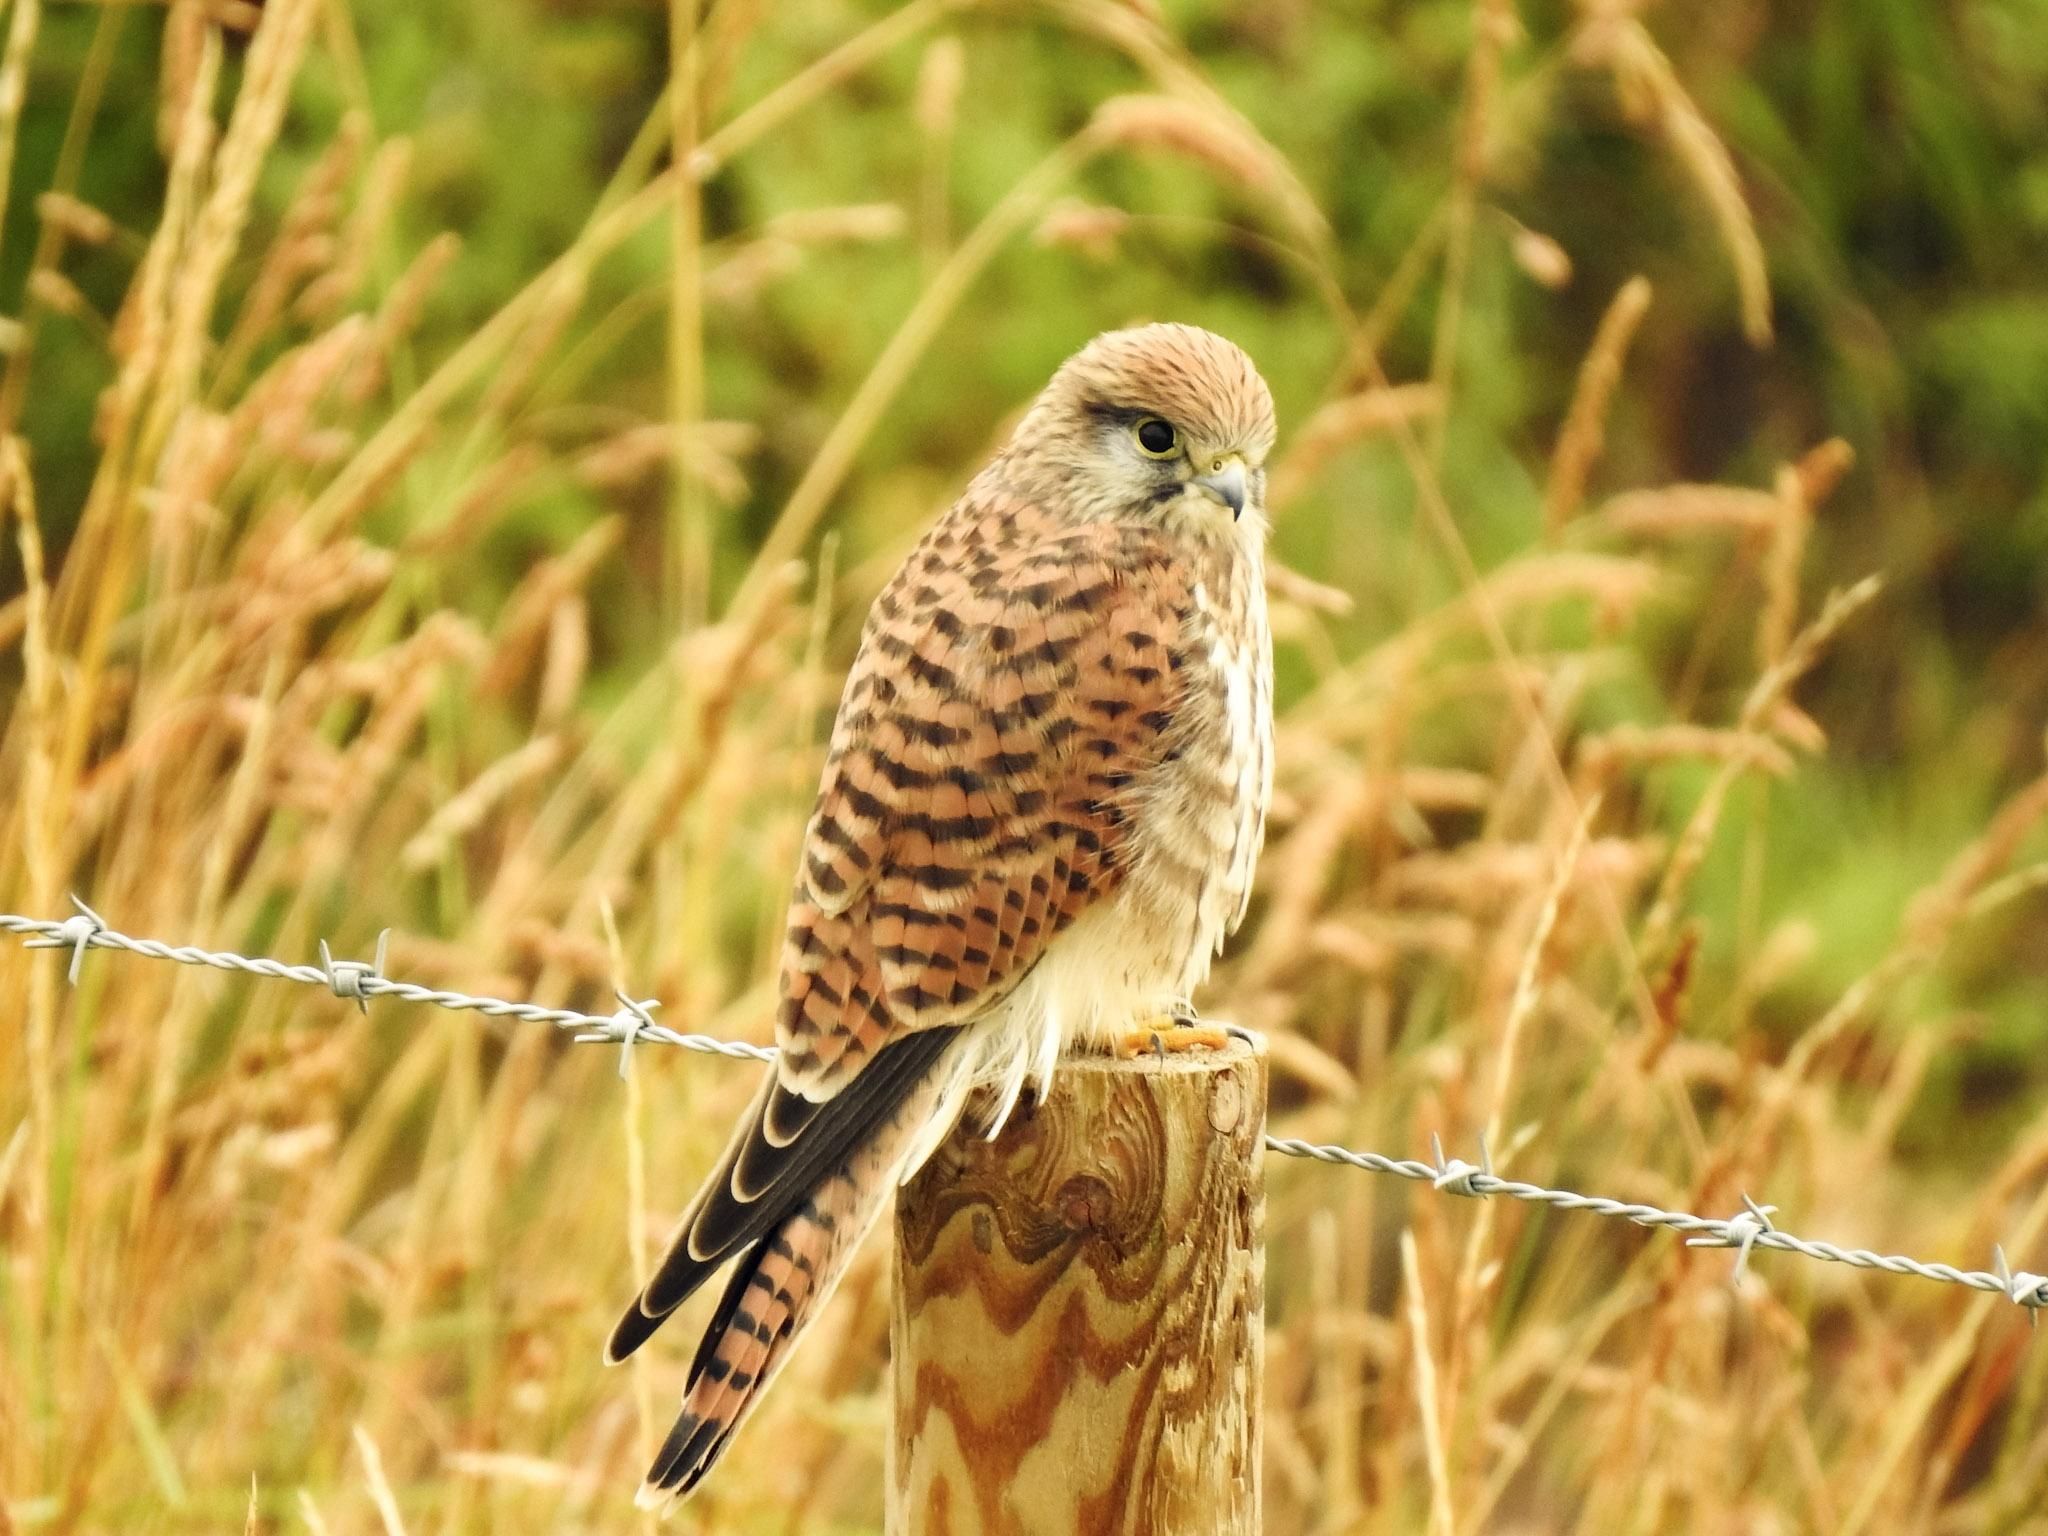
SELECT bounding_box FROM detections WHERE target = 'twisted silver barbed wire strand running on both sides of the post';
[0,897,2048,1323]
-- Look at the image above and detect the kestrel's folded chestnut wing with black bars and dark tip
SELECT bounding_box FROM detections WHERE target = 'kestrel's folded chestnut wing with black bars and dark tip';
[608,496,1190,1358]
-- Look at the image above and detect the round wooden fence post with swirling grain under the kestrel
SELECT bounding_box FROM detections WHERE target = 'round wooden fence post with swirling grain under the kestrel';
[889,1040,1266,1536]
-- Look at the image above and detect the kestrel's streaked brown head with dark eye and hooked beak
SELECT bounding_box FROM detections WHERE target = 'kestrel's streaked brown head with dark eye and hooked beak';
[1010,326,1274,537]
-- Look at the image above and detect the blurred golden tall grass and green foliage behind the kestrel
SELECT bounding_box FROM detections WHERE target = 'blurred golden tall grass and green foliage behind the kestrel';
[0,0,2048,1536]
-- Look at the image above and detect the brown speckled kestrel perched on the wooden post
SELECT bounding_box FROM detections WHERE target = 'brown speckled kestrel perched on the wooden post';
[606,326,1274,1507]
